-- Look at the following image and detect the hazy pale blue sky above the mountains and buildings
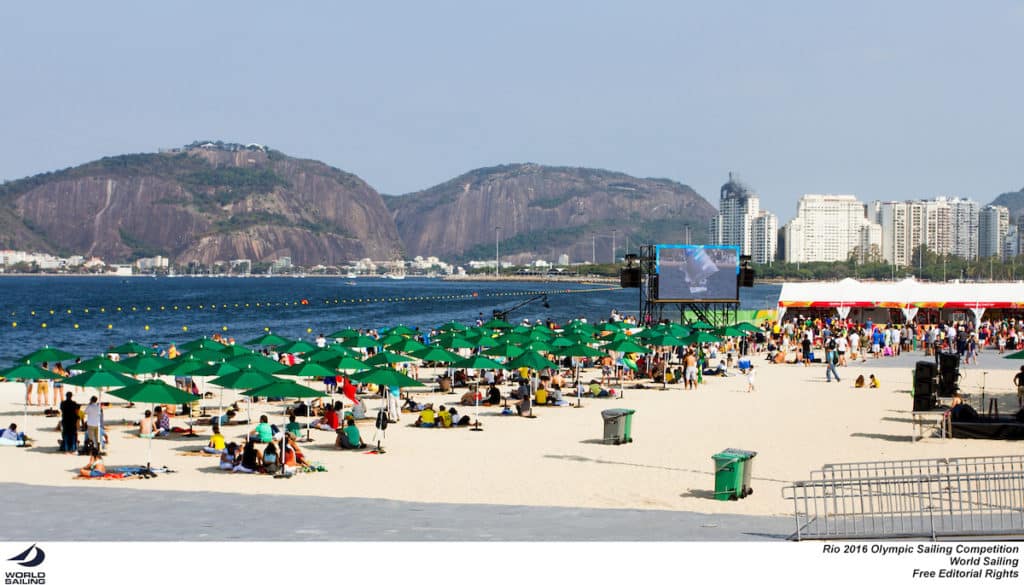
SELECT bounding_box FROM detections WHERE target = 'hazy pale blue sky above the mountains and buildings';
[0,0,1024,221]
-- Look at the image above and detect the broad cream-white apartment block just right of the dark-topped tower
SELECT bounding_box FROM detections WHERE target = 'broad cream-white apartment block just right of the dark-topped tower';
[783,195,882,262]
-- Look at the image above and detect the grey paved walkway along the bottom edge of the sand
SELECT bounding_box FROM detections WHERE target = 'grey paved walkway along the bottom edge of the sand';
[0,477,795,541]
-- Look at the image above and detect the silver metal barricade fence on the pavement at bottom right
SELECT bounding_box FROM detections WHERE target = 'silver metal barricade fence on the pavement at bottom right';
[782,456,1024,540]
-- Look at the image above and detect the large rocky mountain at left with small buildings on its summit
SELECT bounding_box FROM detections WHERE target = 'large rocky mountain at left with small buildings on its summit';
[0,142,401,265]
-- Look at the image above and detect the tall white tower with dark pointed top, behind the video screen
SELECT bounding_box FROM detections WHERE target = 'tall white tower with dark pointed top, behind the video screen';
[709,173,778,264]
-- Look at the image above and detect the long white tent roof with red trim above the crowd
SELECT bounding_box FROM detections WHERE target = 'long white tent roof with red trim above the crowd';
[778,279,1024,308]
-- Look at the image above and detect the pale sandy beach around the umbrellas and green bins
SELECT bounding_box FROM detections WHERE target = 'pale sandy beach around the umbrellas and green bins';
[0,351,1020,515]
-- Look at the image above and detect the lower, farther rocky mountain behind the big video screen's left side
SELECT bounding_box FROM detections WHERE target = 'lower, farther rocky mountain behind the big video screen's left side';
[385,164,716,262]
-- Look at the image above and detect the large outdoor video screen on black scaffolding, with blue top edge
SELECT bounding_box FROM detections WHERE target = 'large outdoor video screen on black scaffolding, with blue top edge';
[638,244,753,326]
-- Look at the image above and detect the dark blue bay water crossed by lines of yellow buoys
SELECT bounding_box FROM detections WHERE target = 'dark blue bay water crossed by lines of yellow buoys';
[0,277,780,365]
